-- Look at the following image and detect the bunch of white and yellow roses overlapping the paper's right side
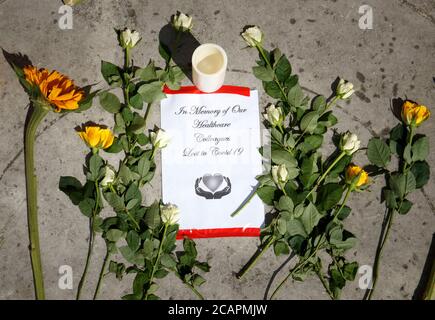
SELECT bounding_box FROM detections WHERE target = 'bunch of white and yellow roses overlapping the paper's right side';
[237,26,369,299]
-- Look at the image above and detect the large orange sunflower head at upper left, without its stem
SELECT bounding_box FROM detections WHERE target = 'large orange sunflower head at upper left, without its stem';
[23,66,84,112]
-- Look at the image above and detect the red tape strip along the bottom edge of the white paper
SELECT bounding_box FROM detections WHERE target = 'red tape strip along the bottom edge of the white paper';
[177,228,260,240]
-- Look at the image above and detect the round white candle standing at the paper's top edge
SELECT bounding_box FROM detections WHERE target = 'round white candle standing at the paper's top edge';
[192,43,228,92]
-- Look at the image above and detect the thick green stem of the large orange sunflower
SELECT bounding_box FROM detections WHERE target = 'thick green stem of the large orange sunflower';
[24,105,48,300]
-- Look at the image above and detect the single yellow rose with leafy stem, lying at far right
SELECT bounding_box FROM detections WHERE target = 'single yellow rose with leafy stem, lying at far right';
[364,100,430,300]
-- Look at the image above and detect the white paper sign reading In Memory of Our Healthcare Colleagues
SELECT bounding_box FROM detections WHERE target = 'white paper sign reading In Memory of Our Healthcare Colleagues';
[161,90,264,237]
